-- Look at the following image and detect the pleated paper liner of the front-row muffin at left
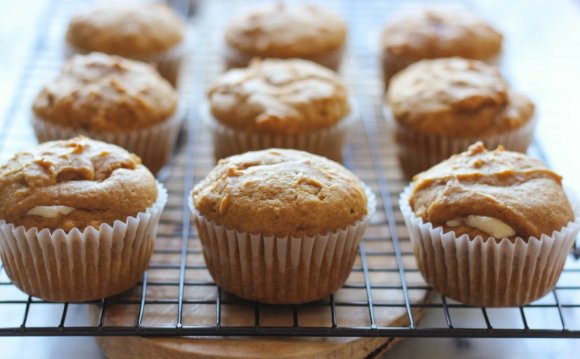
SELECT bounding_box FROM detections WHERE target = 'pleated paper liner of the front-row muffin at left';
[0,184,167,302]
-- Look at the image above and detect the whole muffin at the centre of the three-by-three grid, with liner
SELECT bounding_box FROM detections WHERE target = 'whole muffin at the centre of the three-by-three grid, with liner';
[205,59,351,162]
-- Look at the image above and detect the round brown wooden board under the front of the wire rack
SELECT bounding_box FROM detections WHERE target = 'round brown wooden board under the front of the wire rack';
[90,266,427,359]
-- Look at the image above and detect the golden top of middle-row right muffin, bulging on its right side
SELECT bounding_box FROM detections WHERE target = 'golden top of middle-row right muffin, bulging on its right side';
[387,57,534,137]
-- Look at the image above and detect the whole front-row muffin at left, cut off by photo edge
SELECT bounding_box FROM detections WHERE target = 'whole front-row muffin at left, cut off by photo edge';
[0,137,167,301]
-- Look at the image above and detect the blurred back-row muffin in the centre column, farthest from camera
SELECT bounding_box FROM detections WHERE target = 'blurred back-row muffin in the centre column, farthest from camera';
[225,3,347,71]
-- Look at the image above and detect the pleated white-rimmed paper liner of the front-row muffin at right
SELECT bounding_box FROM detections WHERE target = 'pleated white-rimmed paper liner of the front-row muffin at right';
[399,186,580,307]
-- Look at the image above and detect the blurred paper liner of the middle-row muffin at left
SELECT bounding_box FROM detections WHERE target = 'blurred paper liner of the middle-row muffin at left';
[31,106,185,173]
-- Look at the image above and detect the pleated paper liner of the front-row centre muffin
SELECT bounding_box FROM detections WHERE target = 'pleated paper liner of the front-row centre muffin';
[189,185,376,304]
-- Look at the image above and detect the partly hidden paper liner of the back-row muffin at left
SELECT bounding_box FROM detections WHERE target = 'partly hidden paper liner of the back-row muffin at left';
[64,43,187,88]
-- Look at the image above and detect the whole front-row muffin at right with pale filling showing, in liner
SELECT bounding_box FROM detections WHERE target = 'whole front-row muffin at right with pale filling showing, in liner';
[399,142,580,307]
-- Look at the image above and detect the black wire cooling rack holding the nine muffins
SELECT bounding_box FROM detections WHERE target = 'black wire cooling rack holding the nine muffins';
[0,0,580,338]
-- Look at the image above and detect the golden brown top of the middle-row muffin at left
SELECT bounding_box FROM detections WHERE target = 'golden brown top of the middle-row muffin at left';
[32,53,178,132]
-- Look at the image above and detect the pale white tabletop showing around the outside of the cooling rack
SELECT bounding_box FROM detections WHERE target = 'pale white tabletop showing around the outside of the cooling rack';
[0,0,580,359]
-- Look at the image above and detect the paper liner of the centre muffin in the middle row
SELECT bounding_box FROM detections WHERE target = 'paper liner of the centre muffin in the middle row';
[200,104,357,162]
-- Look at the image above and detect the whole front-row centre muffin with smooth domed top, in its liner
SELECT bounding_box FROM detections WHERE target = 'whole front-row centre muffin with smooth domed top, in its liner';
[190,149,375,304]
